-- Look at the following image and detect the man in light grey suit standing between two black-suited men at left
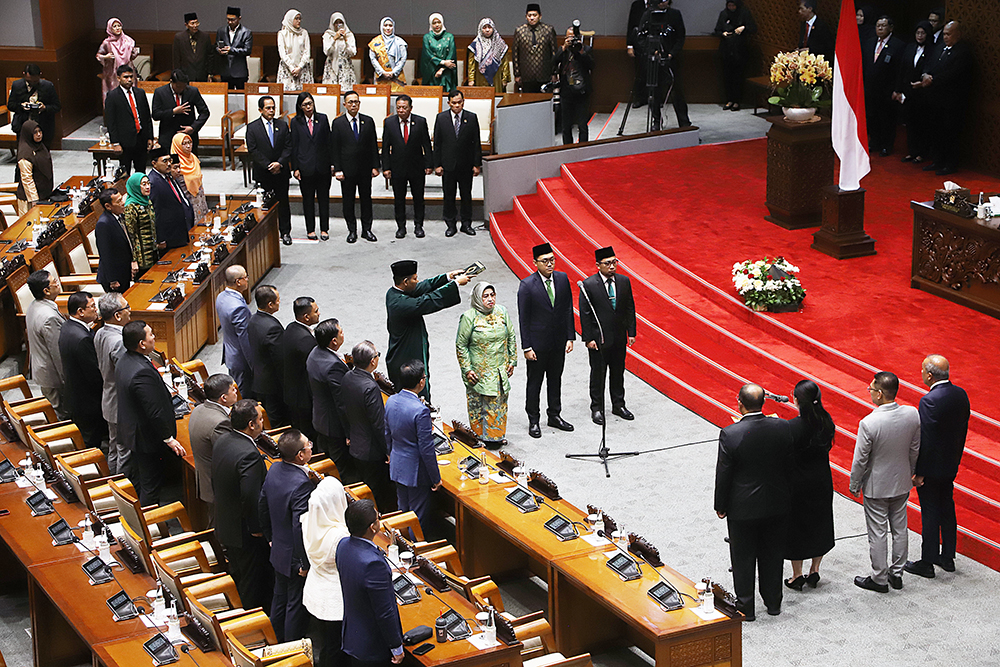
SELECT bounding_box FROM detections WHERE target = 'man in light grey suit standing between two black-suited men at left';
[94,292,132,478]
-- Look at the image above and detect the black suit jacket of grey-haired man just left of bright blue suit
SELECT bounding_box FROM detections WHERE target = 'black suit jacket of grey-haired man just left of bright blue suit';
[340,368,389,461]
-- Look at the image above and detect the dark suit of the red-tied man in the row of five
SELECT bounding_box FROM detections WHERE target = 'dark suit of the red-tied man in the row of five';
[382,113,434,231]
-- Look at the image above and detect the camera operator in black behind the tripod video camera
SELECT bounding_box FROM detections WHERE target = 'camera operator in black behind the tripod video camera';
[635,0,691,131]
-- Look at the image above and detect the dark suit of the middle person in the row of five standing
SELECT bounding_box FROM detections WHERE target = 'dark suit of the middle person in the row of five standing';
[330,113,379,234]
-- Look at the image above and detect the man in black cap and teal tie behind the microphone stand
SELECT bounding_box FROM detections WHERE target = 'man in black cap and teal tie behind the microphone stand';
[580,246,635,425]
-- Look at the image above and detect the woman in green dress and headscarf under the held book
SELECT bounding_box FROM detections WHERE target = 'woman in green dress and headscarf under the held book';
[455,282,517,441]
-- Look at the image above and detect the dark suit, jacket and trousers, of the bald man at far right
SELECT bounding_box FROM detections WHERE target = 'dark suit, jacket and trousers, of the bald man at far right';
[916,384,970,564]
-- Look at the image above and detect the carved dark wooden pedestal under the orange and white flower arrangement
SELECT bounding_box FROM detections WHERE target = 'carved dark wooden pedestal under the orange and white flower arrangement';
[764,116,833,229]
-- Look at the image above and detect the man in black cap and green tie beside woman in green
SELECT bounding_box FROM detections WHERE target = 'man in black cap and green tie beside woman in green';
[517,243,576,438]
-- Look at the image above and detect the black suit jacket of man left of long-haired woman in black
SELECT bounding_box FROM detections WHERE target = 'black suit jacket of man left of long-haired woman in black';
[715,414,793,521]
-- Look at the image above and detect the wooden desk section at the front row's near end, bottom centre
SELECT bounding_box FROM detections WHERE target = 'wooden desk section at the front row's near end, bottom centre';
[549,550,743,667]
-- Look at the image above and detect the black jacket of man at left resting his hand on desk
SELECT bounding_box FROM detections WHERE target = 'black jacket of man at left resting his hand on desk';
[115,352,177,454]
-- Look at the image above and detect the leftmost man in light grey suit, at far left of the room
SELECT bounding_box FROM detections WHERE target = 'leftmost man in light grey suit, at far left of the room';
[25,269,69,419]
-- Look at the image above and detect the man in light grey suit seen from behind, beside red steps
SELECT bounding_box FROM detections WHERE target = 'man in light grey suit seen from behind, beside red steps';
[851,371,920,593]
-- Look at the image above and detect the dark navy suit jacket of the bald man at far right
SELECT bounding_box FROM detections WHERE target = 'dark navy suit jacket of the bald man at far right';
[916,384,970,480]
